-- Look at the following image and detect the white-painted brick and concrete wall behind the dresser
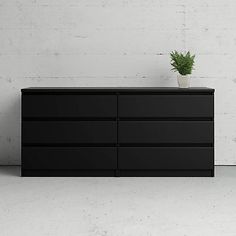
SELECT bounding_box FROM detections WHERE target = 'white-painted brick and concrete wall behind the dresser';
[0,0,236,164]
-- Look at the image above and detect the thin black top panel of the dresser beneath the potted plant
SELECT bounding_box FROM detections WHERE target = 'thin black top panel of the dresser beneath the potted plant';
[21,87,215,93]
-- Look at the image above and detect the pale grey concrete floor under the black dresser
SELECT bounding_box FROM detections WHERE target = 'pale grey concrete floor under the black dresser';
[0,167,236,236]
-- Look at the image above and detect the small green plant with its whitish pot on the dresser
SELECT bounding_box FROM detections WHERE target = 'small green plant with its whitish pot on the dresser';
[170,51,195,88]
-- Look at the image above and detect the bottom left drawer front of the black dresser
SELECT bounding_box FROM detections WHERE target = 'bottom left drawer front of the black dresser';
[22,147,117,170]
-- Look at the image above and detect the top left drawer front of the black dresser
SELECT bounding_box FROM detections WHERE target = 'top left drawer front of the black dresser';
[22,95,117,117]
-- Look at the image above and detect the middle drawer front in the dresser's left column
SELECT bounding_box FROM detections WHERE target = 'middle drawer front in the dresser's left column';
[22,121,117,144]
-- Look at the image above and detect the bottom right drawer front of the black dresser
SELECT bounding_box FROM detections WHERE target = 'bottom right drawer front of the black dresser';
[118,147,214,170]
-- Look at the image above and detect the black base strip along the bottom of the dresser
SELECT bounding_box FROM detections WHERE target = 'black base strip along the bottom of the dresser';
[21,170,214,177]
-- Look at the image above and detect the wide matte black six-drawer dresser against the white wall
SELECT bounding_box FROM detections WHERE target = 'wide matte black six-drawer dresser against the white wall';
[21,87,214,176]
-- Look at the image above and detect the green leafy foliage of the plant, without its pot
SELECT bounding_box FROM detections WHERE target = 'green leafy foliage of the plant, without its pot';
[170,51,195,75]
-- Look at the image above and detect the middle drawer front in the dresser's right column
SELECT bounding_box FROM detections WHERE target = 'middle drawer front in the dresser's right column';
[118,121,214,144]
